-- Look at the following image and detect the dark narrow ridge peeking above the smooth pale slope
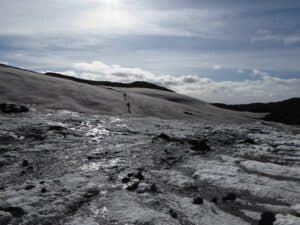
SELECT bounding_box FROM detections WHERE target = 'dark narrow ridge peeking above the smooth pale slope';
[45,72,174,92]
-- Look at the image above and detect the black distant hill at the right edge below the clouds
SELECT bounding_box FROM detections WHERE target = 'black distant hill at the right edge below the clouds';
[212,98,300,125]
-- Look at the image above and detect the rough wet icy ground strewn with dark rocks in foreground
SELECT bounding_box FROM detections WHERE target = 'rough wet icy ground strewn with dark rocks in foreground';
[0,110,300,225]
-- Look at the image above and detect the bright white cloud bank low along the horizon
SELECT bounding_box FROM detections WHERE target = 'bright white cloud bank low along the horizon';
[61,61,300,103]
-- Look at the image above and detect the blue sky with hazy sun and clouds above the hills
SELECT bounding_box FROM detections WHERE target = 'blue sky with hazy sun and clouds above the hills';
[0,0,300,104]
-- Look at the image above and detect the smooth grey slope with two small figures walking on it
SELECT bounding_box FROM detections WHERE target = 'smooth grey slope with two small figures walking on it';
[0,65,257,121]
